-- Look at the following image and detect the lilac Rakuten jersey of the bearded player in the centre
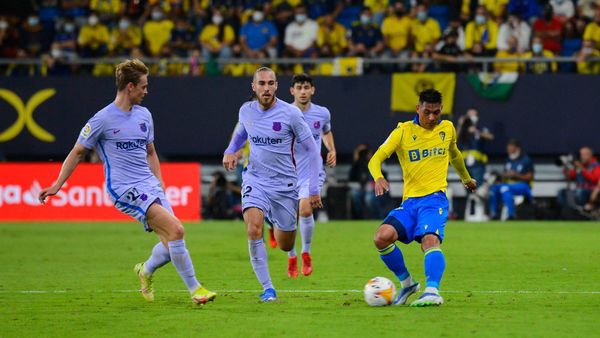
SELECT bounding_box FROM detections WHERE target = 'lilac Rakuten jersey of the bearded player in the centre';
[236,99,311,188]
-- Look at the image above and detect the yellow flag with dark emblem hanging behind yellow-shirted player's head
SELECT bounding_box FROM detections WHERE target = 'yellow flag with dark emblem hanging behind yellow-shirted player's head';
[391,73,456,114]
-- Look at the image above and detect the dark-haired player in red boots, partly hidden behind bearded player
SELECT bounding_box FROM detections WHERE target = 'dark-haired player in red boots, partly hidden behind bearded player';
[288,74,336,278]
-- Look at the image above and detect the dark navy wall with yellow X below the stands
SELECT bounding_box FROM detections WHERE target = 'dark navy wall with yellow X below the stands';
[0,74,600,159]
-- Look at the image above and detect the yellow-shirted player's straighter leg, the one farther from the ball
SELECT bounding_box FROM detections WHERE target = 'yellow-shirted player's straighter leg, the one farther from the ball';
[411,192,448,306]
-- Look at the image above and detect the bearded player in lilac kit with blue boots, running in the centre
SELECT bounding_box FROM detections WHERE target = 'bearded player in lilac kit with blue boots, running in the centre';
[223,67,323,302]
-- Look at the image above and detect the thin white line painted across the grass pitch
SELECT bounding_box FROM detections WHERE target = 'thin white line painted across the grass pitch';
[0,289,600,295]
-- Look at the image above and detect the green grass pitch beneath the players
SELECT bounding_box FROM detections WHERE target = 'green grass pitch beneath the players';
[0,221,600,337]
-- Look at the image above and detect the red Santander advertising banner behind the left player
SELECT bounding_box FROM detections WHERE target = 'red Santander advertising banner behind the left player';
[0,163,201,221]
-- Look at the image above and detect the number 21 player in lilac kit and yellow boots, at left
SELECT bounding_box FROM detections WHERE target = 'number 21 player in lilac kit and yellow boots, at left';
[39,59,217,304]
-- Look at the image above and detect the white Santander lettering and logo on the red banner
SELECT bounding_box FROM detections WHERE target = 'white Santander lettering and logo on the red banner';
[0,181,192,207]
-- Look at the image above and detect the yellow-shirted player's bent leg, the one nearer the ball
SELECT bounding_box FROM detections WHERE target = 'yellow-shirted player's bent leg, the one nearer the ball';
[373,201,420,305]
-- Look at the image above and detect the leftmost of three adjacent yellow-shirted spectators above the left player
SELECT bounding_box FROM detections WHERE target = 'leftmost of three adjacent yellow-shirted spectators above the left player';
[77,13,110,57]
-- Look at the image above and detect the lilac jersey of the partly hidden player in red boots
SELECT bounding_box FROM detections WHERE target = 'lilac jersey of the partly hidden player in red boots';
[295,103,331,176]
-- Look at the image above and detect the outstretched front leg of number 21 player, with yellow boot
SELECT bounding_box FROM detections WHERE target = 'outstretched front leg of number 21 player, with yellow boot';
[146,203,217,304]
